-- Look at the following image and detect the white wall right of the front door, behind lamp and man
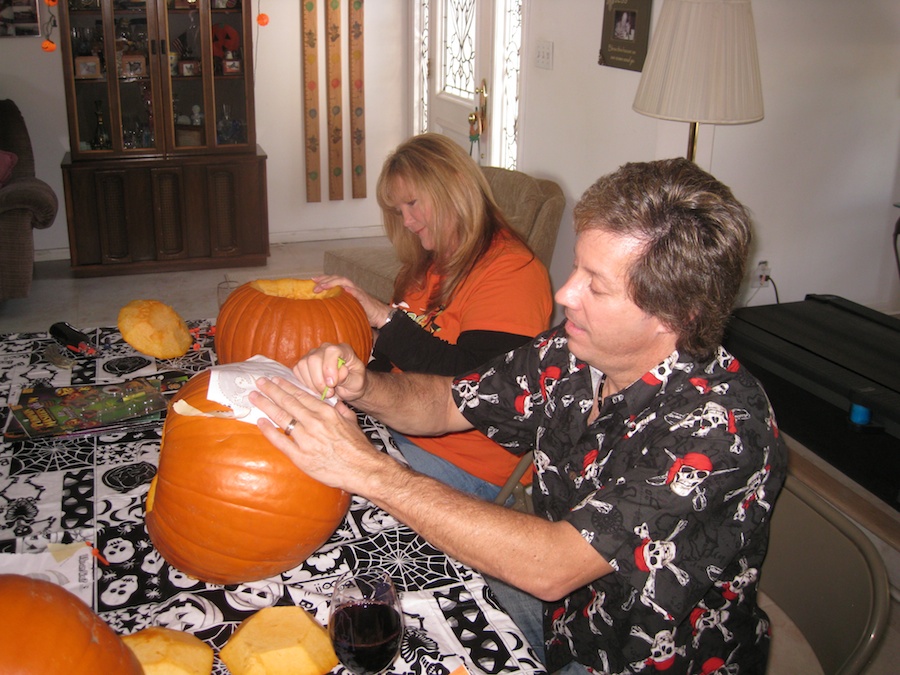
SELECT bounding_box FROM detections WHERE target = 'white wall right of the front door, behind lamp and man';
[521,0,900,320]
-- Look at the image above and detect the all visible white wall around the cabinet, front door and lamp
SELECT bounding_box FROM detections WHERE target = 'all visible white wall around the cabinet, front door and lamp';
[0,0,900,312]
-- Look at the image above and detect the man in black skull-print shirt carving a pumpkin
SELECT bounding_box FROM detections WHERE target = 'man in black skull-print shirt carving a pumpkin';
[251,159,786,675]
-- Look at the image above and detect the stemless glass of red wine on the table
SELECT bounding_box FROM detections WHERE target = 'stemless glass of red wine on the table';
[328,569,403,675]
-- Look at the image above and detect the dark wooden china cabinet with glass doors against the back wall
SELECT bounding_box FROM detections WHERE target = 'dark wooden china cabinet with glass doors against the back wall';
[59,0,269,276]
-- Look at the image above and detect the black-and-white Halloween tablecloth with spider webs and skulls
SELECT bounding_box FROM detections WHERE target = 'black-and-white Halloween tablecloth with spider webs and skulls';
[0,321,544,675]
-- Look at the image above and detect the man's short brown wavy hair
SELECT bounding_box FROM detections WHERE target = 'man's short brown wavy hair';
[574,159,750,357]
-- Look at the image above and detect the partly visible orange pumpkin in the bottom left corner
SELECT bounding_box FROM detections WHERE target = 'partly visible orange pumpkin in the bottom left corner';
[0,574,144,675]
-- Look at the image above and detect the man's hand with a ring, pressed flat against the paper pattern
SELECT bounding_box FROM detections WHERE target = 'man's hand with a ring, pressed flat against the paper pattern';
[250,378,387,494]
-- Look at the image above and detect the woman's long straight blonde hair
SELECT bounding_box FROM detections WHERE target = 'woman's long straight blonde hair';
[376,133,524,310]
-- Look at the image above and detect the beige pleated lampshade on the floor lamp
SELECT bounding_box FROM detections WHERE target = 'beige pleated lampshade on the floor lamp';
[634,0,763,124]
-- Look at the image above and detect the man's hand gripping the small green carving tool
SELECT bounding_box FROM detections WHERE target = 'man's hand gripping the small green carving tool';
[293,342,368,401]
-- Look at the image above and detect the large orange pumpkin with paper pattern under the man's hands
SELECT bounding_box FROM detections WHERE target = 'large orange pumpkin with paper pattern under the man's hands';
[146,371,350,584]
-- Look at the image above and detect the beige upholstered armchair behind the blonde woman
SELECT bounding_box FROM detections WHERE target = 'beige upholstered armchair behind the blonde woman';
[324,166,566,302]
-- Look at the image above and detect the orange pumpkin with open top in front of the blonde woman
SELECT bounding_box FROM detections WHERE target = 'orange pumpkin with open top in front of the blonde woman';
[216,279,372,368]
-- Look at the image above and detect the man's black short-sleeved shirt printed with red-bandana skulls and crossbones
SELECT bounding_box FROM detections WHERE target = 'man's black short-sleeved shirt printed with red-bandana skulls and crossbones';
[455,328,786,675]
